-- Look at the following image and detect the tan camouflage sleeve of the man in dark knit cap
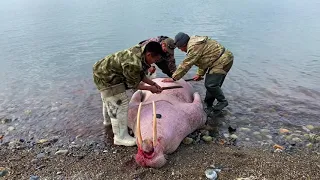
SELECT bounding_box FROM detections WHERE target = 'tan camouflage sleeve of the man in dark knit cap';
[172,51,200,81]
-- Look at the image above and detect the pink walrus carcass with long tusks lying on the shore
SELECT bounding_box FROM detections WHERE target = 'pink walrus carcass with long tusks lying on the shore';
[128,78,206,168]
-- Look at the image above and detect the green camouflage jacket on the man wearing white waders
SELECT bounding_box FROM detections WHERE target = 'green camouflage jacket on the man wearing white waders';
[93,45,150,91]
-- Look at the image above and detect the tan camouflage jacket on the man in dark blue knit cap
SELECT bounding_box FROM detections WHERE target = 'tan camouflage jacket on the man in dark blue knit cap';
[172,36,233,80]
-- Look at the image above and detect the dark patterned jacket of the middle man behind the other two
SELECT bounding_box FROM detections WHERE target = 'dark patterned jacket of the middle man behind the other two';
[139,36,177,77]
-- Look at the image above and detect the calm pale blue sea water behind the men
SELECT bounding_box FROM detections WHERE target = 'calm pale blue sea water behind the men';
[0,0,320,146]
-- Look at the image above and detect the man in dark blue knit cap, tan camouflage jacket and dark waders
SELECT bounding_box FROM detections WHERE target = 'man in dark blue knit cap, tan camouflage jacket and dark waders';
[163,32,233,116]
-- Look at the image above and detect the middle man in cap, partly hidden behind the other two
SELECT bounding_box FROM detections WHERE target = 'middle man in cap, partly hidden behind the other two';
[139,36,177,77]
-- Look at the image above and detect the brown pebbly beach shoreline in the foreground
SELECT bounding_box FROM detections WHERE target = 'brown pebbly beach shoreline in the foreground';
[0,138,320,179]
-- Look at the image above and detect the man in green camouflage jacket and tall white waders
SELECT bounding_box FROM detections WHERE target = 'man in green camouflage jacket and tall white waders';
[93,42,163,146]
